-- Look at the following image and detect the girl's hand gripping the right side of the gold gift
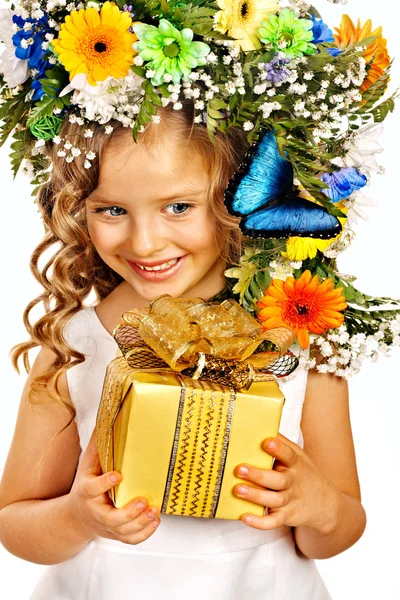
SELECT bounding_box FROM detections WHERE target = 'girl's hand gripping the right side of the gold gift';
[233,433,339,532]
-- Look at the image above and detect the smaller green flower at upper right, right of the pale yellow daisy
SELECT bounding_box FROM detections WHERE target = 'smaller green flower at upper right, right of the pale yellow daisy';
[258,8,317,58]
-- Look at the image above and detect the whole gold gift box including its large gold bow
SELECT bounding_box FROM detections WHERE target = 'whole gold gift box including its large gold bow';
[96,295,298,519]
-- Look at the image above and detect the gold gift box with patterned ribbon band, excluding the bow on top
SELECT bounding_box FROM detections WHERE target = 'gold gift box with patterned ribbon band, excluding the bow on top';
[99,358,285,519]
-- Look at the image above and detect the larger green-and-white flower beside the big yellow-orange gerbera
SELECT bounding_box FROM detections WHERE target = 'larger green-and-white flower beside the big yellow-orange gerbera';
[133,19,210,85]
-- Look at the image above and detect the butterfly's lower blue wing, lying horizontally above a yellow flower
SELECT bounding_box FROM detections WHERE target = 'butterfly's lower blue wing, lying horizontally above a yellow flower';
[240,195,342,239]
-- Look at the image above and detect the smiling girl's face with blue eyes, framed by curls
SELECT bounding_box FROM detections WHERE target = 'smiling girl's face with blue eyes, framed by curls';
[86,130,225,301]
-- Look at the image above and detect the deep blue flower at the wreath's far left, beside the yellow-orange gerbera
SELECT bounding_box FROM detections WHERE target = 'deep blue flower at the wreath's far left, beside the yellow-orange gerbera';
[12,15,52,101]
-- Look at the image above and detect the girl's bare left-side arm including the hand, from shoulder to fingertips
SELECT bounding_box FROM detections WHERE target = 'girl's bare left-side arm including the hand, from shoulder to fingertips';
[0,348,160,564]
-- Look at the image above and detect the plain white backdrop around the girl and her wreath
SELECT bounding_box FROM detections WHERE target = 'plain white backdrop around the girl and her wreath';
[0,0,400,600]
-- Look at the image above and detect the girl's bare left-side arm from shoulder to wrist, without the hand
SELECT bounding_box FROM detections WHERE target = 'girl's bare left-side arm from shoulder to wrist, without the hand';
[0,348,90,564]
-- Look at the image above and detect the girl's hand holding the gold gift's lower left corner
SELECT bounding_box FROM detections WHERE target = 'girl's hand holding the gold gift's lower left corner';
[69,431,160,544]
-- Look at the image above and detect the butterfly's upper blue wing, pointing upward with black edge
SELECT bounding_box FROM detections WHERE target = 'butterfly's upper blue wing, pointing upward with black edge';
[225,131,293,216]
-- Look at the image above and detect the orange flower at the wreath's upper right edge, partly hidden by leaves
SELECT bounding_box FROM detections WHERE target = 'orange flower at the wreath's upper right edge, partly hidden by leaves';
[334,15,390,92]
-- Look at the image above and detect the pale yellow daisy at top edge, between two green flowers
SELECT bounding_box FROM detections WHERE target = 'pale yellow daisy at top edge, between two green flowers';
[214,0,279,51]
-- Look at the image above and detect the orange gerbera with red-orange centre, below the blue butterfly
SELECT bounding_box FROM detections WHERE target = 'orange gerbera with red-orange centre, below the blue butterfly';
[257,271,347,350]
